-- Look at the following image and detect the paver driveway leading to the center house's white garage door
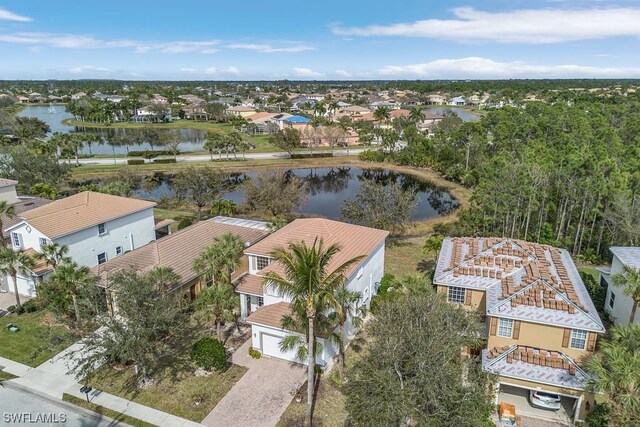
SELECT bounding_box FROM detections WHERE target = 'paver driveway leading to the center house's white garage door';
[201,339,307,427]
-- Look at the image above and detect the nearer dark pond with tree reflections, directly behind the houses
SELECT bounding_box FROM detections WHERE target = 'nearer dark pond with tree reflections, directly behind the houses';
[134,166,459,221]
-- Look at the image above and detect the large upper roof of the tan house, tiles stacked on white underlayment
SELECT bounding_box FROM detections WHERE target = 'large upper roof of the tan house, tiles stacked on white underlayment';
[434,237,604,332]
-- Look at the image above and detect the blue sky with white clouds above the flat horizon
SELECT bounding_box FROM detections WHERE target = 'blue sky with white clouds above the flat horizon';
[0,0,640,80]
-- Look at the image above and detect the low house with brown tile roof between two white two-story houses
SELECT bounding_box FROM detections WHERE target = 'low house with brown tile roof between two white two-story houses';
[92,217,269,313]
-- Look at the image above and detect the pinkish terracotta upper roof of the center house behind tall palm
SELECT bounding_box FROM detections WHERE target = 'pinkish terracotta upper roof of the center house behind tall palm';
[245,218,389,277]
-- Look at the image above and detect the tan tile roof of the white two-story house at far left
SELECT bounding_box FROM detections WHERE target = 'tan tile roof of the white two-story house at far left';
[12,191,156,239]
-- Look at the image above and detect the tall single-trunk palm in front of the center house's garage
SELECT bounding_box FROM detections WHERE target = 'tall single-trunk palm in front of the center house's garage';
[265,238,362,426]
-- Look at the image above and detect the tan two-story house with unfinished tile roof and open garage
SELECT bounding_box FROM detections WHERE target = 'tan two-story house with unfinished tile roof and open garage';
[434,238,605,425]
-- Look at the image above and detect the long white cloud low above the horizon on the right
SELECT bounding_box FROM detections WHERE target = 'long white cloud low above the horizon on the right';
[378,57,640,79]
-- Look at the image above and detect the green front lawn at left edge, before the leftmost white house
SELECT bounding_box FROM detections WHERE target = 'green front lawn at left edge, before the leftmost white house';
[0,310,71,367]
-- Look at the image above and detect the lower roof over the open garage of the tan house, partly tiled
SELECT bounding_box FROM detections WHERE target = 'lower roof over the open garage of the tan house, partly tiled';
[482,345,589,390]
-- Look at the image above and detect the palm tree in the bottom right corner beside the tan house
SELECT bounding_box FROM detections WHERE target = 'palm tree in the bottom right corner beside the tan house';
[584,324,640,427]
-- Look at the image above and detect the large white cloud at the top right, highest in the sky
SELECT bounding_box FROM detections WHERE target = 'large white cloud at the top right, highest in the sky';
[333,7,640,44]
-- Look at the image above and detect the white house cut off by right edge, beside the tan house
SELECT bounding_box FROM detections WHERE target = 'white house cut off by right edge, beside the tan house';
[598,246,640,325]
